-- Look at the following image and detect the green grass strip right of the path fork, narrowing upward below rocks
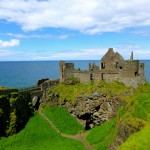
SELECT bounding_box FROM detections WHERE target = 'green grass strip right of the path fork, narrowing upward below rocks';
[86,107,125,150]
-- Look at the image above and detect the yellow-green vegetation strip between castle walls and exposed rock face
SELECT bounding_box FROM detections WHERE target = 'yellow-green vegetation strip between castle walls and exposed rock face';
[47,81,131,104]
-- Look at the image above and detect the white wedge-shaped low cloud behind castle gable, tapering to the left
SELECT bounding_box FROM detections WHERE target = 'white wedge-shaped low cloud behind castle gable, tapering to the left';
[44,44,150,60]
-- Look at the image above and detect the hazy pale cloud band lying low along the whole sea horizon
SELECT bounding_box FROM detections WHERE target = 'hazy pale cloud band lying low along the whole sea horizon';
[0,48,150,60]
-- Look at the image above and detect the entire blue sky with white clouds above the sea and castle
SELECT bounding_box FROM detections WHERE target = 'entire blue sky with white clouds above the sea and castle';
[0,0,150,61]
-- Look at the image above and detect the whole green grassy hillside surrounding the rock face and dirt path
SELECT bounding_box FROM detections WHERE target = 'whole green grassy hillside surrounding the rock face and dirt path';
[0,82,150,150]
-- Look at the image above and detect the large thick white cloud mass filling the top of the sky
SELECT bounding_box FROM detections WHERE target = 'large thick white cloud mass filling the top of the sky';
[0,0,150,34]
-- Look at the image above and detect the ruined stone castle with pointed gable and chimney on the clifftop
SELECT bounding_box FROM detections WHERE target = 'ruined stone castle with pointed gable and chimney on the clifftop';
[59,48,146,87]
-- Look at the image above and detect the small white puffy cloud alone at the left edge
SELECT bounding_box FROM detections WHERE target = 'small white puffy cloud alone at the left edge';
[0,39,20,48]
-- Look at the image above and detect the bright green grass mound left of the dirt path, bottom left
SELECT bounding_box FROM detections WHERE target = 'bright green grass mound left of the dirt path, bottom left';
[0,114,85,150]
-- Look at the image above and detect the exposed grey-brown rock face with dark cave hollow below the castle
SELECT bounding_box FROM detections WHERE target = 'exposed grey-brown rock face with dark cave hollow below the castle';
[49,91,123,129]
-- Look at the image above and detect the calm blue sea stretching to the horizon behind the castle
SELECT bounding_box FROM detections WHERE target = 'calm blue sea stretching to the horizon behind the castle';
[0,60,150,89]
